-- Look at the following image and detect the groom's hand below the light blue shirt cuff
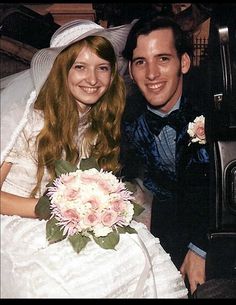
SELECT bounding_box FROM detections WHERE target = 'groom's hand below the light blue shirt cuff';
[180,250,205,294]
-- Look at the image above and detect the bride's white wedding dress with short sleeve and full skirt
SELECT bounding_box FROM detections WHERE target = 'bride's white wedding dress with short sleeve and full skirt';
[1,108,187,298]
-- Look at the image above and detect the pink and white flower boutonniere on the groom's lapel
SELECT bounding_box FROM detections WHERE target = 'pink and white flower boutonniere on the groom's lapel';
[187,115,206,145]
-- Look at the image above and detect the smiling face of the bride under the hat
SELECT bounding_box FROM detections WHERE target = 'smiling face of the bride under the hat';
[67,46,112,112]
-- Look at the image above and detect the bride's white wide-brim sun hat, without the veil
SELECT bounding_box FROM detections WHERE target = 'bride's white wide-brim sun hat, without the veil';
[31,19,132,93]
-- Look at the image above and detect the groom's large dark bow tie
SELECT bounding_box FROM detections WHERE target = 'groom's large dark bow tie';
[145,110,185,136]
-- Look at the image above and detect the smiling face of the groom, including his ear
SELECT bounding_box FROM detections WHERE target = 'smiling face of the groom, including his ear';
[129,29,190,112]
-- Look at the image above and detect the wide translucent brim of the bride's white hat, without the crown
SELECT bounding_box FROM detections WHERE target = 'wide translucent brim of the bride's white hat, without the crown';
[31,24,132,93]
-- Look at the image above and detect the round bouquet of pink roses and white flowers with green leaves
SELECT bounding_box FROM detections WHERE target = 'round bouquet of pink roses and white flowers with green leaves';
[35,158,143,253]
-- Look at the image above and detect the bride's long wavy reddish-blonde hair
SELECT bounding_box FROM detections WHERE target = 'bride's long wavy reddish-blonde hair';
[31,36,125,196]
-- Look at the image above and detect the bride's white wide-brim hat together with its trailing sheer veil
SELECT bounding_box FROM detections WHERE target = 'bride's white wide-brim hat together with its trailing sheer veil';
[0,19,133,163]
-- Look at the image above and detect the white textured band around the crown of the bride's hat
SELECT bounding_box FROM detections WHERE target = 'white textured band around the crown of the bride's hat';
[51,24,103,48]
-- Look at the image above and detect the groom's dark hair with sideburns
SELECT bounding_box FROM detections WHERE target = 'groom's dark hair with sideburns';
[122,16,193,60]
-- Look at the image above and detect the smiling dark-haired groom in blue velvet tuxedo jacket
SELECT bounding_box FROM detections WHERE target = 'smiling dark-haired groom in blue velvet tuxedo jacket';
[121,16,209,293]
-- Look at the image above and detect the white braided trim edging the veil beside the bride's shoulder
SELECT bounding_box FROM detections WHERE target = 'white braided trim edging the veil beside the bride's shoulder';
[1,91,36,164]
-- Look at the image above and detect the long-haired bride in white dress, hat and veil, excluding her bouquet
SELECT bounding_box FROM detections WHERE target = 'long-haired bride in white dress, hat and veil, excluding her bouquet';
[1,20,187,298]
